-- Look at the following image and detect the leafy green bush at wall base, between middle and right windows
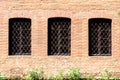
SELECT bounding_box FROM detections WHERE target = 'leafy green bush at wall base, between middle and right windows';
[68,68,82,80]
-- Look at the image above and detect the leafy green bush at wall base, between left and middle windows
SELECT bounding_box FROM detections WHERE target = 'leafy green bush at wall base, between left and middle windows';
[27,69,44,80]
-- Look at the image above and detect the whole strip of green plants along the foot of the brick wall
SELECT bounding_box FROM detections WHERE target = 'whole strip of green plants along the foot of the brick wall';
[0,68,120,80]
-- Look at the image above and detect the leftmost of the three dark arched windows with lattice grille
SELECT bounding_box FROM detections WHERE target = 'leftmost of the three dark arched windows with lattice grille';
[9,18,31,55]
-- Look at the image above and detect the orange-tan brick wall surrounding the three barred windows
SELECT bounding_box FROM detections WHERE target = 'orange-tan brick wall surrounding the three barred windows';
[0,0,120,75]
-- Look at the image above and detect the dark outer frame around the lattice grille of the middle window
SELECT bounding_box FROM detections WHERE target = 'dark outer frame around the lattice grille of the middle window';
[47,17,71,56]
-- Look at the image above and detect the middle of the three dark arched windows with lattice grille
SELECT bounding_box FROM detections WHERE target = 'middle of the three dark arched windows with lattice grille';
[48,17,71,56]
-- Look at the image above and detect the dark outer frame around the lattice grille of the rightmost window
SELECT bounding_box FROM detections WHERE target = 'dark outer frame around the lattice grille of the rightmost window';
[88,18,112,56]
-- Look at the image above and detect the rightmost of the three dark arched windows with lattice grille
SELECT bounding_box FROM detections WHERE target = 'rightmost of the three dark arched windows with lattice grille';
[89,18,112,56]
